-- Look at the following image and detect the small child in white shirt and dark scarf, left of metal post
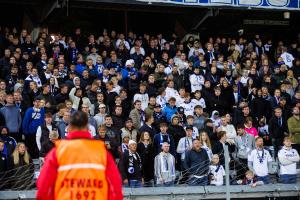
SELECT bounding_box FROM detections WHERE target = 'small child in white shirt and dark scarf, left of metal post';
[209,154,225,186]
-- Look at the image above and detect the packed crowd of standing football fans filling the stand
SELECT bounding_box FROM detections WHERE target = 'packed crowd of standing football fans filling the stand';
[0,28,300,187]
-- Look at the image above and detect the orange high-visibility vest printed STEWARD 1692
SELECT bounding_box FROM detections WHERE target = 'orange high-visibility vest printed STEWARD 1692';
[54,139,108,200]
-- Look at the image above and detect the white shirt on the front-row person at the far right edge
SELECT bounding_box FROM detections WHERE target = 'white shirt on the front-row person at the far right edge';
[278,147,299,174]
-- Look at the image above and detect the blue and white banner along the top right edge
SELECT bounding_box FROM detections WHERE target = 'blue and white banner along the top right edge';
[136,0,300,11]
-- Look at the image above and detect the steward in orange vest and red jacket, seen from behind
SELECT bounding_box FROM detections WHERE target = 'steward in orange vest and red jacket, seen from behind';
[36,111,123,200]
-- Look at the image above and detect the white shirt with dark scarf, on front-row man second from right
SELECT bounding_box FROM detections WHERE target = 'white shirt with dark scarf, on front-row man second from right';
[248,149,272,176]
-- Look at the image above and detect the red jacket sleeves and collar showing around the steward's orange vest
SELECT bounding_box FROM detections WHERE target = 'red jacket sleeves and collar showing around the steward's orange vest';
[36,131,123,200]
